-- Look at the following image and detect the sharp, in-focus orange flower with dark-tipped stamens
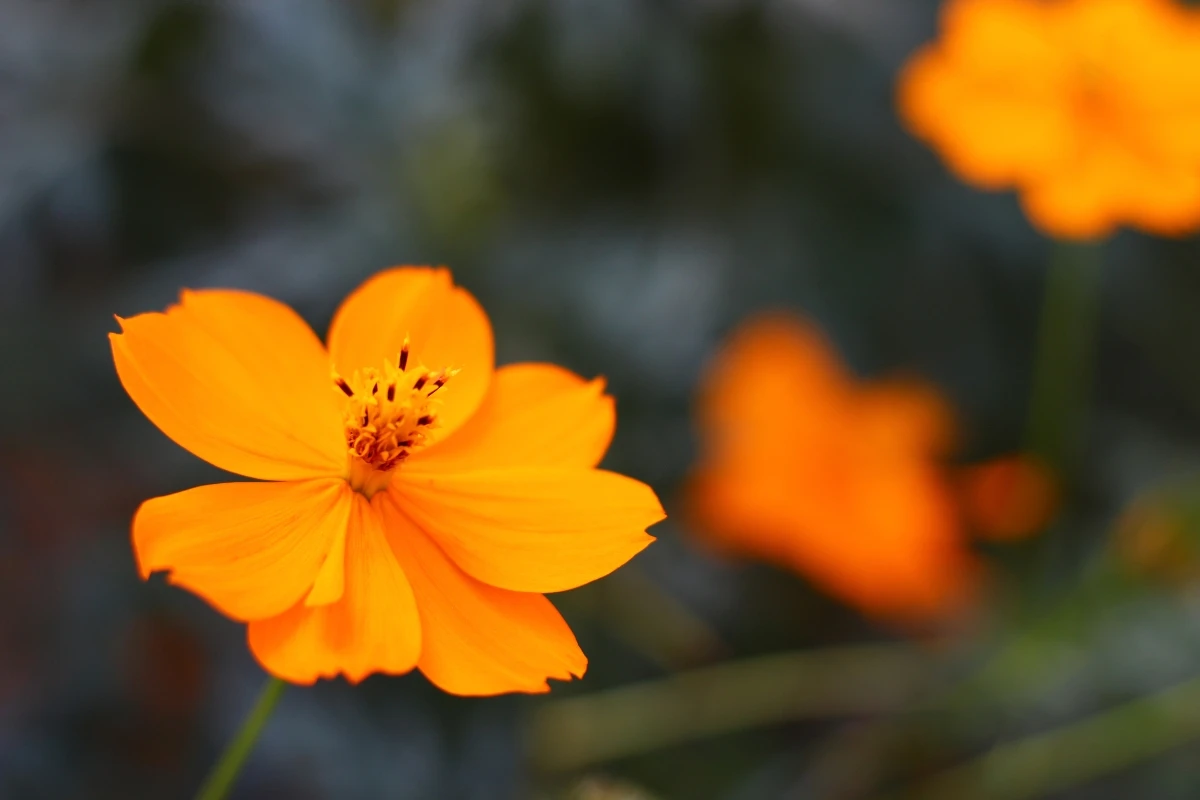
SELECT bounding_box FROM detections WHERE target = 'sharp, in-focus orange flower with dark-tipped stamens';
[109,267,664,694]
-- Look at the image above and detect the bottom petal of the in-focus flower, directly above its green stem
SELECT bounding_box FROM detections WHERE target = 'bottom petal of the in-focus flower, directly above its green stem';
[248,493,421,684]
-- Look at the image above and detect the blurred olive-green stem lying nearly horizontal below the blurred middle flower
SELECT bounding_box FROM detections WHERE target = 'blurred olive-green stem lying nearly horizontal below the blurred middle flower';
[529,645,930,771]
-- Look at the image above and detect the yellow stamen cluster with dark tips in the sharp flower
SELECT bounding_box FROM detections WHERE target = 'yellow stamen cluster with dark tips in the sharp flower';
[334,339,458,497]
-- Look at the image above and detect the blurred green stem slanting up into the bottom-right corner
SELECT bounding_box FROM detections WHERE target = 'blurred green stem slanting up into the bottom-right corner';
[896,678,1200,800]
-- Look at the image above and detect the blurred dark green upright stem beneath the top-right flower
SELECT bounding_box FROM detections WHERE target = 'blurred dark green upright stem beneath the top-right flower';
[1026,242,1102,475]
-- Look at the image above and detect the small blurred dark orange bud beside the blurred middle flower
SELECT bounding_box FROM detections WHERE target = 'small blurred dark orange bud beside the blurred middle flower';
[959,456,1058,541]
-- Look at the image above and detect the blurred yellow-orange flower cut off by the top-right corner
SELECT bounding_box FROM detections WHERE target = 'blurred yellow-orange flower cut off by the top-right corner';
[899,0,1200,239]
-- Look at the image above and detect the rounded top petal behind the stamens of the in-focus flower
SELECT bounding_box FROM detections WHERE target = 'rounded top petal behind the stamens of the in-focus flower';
[329,266,494,440]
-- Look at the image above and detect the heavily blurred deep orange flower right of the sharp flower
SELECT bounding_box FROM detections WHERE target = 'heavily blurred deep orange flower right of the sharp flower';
[689,317,974,620]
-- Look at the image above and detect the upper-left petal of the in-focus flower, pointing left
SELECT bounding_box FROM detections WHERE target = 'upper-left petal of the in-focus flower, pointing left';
[109,290,346,480]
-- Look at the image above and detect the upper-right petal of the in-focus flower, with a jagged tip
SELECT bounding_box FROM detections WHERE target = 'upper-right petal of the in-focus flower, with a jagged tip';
[408,363,617,471]
